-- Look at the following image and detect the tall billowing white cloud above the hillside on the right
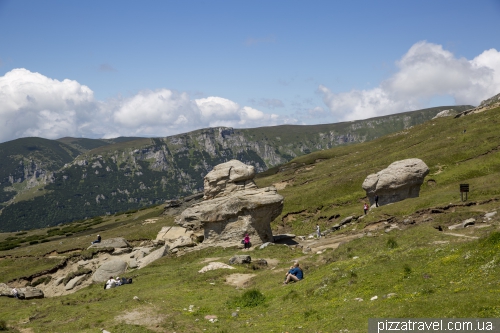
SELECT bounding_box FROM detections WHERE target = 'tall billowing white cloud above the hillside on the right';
[318,41,500,120]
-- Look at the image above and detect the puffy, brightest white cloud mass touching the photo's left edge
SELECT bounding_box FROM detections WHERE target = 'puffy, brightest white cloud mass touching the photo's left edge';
[0,69,95,142]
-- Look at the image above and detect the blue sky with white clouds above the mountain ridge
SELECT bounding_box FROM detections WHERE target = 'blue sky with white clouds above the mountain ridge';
[0,0,500,142]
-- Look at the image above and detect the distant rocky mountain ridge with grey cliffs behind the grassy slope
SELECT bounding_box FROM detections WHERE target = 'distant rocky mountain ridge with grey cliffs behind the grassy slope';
[0,106,471,231]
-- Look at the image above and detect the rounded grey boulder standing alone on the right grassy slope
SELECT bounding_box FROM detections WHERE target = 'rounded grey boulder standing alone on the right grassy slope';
[362,158,429,205]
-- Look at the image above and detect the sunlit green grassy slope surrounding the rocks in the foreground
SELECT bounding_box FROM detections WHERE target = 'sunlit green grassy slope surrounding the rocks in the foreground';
[0,108,500,333]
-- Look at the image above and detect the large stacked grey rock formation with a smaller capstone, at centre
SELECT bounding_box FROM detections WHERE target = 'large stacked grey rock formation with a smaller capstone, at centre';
[176,160,283,246]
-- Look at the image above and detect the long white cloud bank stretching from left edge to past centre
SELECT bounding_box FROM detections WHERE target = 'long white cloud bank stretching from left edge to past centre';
[0,69,288,142]
